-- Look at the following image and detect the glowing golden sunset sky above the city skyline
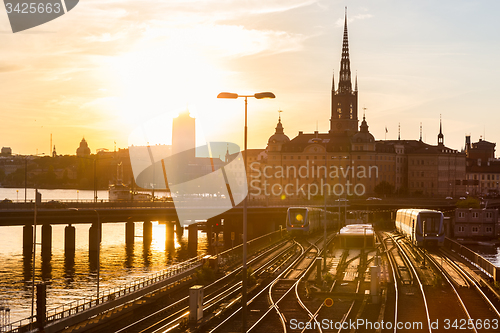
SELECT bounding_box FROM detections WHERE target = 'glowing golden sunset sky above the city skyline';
[0,0,500,154]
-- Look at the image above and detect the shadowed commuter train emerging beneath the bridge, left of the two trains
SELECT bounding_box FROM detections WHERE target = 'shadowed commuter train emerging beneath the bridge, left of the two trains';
[286,207,340,236]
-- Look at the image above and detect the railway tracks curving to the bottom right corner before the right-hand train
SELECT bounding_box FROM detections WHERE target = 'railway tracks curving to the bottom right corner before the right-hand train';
[378,234,500,333]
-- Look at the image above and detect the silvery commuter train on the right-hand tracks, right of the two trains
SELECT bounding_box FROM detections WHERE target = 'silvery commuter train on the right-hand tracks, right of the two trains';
[395,209,444,246]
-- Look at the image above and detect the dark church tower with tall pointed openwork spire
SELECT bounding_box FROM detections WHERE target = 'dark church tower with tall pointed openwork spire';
[330,8,358,136]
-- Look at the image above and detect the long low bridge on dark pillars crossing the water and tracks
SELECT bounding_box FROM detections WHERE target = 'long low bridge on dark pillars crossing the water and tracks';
[0,198,470,254]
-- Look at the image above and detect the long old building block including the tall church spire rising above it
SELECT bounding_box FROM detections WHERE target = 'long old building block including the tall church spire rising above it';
[247,12,466,199]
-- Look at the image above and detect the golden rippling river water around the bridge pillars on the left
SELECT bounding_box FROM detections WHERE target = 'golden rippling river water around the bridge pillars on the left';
[0,188,207,322]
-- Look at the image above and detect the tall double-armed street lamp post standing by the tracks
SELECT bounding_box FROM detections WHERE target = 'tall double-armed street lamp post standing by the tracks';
[217,92,276,332]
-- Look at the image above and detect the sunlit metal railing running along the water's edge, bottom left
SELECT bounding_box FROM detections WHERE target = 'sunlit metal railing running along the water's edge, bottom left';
[0,256,206,332]
